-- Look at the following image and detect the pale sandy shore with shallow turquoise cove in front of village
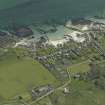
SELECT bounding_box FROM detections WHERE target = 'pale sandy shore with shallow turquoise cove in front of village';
[14,17,105,47]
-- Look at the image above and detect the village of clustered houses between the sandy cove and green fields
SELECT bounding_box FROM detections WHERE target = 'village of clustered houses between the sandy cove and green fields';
[21,19,105,81]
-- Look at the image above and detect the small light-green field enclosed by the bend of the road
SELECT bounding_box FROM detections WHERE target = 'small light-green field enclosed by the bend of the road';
[67,62,89,73]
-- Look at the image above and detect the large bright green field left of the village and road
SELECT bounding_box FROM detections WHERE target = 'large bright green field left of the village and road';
[0,53,58,99]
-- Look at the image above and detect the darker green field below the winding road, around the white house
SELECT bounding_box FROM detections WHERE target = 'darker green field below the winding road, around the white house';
[49,80,105,105]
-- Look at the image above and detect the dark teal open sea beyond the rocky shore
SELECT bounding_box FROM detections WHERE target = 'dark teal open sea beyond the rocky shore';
[0,0,105,39]
